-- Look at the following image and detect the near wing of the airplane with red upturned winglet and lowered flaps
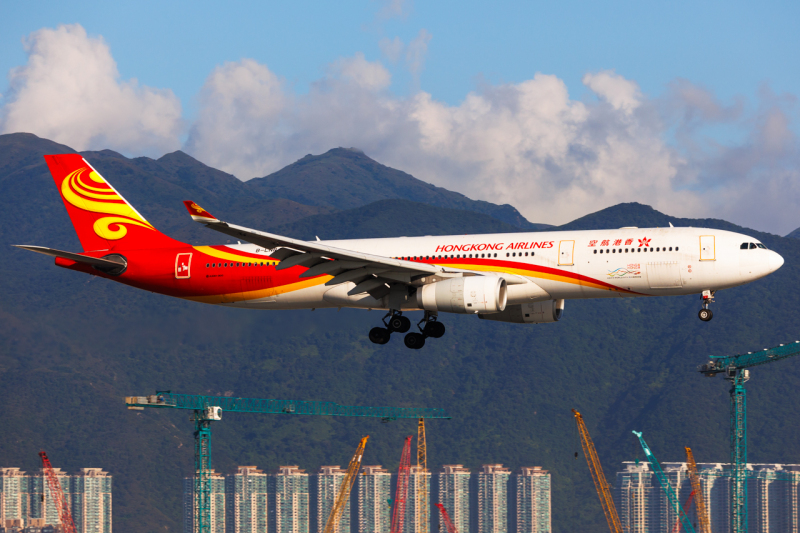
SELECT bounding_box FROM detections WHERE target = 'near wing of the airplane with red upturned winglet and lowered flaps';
[184,201,456,298]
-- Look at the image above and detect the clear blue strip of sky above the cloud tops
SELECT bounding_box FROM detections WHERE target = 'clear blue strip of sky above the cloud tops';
[0,0,800,113]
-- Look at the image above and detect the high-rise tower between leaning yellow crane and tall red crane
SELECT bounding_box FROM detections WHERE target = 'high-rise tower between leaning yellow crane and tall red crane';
[357,465,392,533]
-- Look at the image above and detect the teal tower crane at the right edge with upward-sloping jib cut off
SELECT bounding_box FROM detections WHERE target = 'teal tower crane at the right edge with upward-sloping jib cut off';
[698,341,800,533]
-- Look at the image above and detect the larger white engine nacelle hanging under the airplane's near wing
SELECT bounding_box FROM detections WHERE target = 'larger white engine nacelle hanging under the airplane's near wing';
[417,276,508,314]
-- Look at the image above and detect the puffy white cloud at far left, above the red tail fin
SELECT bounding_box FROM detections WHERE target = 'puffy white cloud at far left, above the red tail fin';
[0,24,183,155]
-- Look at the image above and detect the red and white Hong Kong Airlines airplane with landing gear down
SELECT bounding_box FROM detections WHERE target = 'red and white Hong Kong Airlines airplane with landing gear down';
[16,154,783,349]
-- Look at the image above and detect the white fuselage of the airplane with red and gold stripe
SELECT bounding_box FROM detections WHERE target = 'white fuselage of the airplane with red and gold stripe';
[217,227,783,309]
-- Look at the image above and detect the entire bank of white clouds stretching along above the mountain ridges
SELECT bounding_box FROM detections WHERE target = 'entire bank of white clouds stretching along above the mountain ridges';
[0,26,800,234]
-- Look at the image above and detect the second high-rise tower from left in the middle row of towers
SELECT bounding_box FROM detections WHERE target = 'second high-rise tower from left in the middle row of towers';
[225,466,268,533]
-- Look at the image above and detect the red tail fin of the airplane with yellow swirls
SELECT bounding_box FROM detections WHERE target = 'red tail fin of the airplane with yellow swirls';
[44,154,182,251]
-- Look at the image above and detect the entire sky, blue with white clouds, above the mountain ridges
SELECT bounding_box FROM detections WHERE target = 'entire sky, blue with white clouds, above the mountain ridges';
[0,0,800,233]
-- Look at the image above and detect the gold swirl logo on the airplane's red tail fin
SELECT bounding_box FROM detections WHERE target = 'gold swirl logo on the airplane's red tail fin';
[61,167,155,241]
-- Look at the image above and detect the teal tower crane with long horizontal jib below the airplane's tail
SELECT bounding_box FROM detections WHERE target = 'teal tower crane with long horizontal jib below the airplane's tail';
[125,391,450,533]
